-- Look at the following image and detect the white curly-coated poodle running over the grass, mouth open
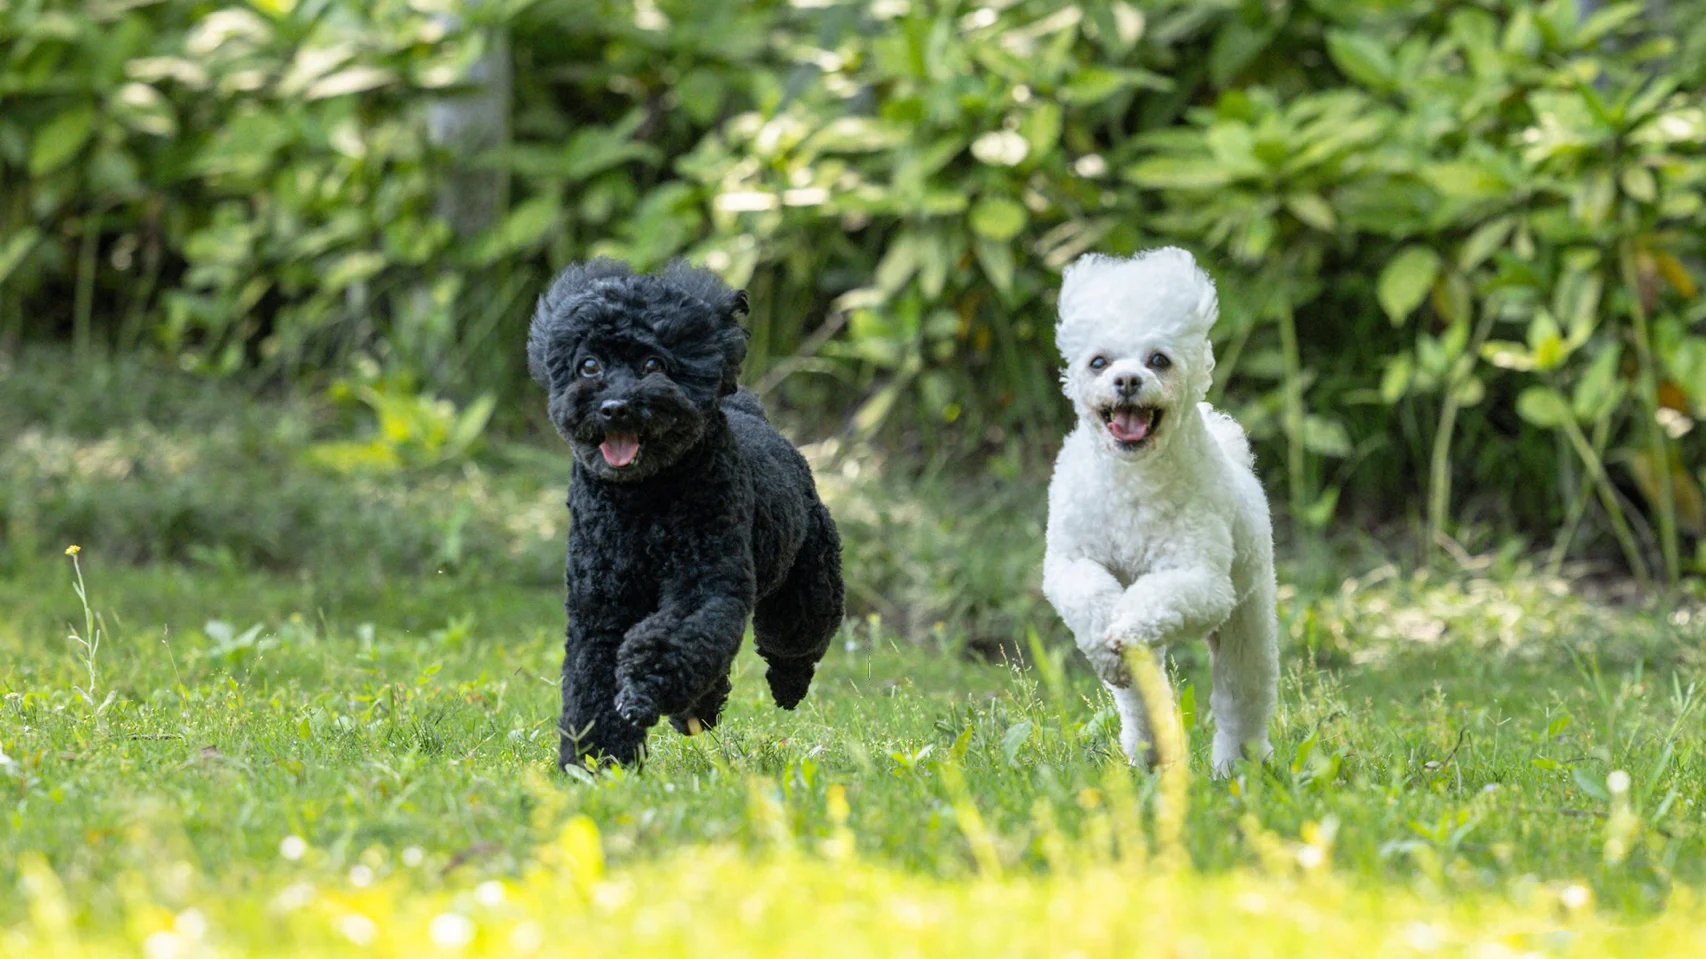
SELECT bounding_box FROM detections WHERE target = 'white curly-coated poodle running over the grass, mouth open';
[1042,247,1280,776]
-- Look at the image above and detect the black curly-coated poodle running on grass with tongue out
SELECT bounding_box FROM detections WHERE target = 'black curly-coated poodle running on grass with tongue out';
[527,259,844,764]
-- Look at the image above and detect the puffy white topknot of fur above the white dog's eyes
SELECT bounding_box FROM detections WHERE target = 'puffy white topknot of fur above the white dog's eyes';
[1054,246,1220,358]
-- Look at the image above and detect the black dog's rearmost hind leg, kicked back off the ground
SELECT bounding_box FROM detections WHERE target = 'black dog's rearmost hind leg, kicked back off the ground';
[752,503,846,710]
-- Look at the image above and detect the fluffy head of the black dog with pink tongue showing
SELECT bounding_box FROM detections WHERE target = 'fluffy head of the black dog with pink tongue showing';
[527,259,747,481]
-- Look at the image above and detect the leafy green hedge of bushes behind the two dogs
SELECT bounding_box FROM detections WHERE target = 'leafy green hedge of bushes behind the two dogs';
[0,0,1706,575]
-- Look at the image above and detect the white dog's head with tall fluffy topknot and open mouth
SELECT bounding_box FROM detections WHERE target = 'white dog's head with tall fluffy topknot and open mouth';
[1054,246,1220,459]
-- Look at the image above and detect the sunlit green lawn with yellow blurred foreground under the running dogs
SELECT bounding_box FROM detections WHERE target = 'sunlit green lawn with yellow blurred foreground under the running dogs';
[0,349,1706,956]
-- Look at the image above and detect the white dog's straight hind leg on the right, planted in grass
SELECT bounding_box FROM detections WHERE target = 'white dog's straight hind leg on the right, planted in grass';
[1210,604,1280,776]
